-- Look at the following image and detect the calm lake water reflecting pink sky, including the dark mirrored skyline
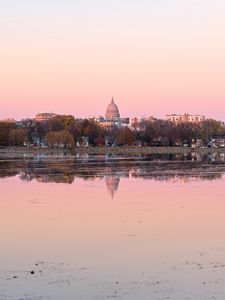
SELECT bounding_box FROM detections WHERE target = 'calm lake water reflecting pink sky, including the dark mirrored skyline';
[0,155,225,300]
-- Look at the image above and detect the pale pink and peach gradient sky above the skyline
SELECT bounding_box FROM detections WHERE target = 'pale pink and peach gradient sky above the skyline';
[0,0,225,121]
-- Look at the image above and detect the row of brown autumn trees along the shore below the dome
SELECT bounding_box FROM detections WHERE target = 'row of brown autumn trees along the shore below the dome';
[0,115,225,147]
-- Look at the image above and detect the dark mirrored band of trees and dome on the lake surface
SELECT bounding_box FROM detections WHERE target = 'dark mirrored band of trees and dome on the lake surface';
[0,153,225,197]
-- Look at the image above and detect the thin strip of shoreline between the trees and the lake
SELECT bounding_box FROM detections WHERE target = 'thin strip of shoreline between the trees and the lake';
[0,147,225,156]
